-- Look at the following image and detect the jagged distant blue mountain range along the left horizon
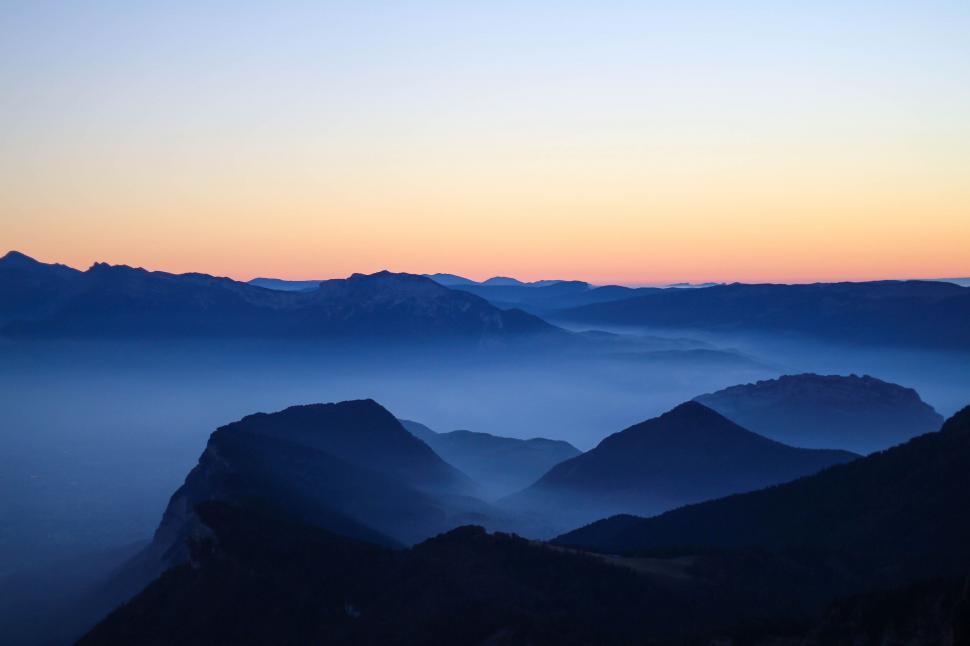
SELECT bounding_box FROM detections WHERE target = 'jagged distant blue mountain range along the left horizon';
[0,255,565,340]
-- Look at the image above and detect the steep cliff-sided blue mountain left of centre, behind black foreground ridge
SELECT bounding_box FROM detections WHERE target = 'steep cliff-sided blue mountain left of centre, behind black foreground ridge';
[149,400,487,564]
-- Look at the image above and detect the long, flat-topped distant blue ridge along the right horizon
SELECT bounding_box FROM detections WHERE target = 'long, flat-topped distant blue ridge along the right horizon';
[251,274,970,351]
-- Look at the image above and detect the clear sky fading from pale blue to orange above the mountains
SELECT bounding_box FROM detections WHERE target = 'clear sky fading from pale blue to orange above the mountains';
[0,0,970,283]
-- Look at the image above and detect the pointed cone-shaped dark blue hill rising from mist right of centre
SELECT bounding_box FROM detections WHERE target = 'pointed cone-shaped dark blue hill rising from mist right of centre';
[500,402,857,522]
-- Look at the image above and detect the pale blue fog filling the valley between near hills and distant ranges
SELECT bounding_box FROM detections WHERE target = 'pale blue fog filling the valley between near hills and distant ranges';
[0,331,970,575]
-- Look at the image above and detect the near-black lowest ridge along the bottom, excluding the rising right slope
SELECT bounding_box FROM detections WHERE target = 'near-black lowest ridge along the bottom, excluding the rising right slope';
[79,502,970,646]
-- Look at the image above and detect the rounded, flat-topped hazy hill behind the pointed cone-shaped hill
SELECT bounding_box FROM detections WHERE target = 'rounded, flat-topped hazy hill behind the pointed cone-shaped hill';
[695,374,943,453]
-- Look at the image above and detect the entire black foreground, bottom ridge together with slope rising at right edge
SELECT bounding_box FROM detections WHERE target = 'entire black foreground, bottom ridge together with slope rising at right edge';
[79,403,970,646]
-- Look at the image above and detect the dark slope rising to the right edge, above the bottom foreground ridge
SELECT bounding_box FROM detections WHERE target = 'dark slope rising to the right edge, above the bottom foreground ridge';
[556,407,970,586]
